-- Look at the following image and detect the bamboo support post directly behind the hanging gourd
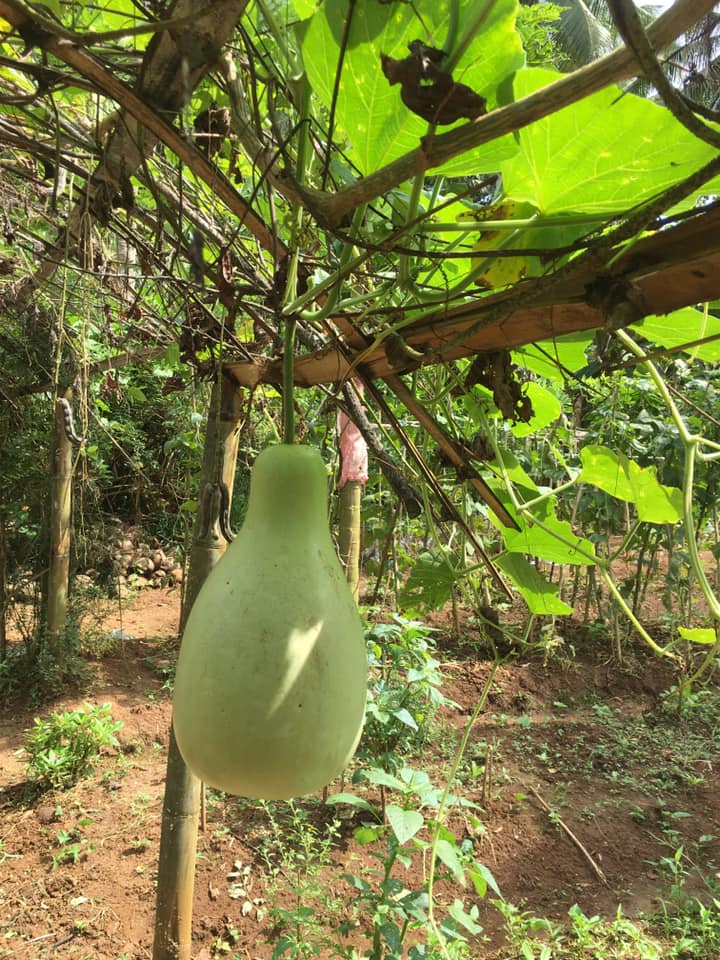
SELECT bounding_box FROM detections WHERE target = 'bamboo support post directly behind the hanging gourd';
[153,377,241,960]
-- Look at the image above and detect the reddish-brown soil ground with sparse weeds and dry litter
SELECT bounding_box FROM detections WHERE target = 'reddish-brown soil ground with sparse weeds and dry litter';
[0,590,720,960]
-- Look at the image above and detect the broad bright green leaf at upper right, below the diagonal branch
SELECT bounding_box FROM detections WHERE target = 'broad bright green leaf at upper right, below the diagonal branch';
[502,68,716,214]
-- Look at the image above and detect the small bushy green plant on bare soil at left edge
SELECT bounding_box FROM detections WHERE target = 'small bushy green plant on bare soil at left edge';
[23,703,122,789]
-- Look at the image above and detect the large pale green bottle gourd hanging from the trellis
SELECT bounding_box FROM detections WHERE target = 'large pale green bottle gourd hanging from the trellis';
[173,444,367,800]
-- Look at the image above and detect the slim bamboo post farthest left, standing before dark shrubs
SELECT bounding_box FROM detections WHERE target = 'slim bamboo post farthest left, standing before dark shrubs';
[45,389,72,644]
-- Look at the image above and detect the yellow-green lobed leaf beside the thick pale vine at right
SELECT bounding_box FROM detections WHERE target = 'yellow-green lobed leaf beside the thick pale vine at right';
[578,444,682,523]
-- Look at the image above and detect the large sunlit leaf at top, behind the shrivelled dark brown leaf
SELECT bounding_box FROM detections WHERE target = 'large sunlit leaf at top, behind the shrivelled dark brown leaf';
[302,0,524,175]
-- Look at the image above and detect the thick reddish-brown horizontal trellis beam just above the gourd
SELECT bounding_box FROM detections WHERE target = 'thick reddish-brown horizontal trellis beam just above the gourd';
[227,209,720,387]
